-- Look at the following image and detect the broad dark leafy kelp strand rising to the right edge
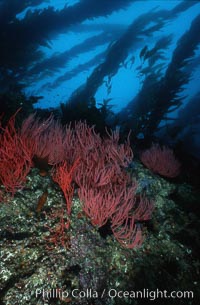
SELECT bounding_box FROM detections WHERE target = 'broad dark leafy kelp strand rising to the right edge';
[118,15,200,137]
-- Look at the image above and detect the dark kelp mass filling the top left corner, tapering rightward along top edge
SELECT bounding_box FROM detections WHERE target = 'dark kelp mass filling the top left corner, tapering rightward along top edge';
[0,0,133,91]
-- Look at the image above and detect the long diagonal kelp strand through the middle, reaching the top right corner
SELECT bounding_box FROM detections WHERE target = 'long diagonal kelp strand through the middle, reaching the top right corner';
[61,2,194,115]
